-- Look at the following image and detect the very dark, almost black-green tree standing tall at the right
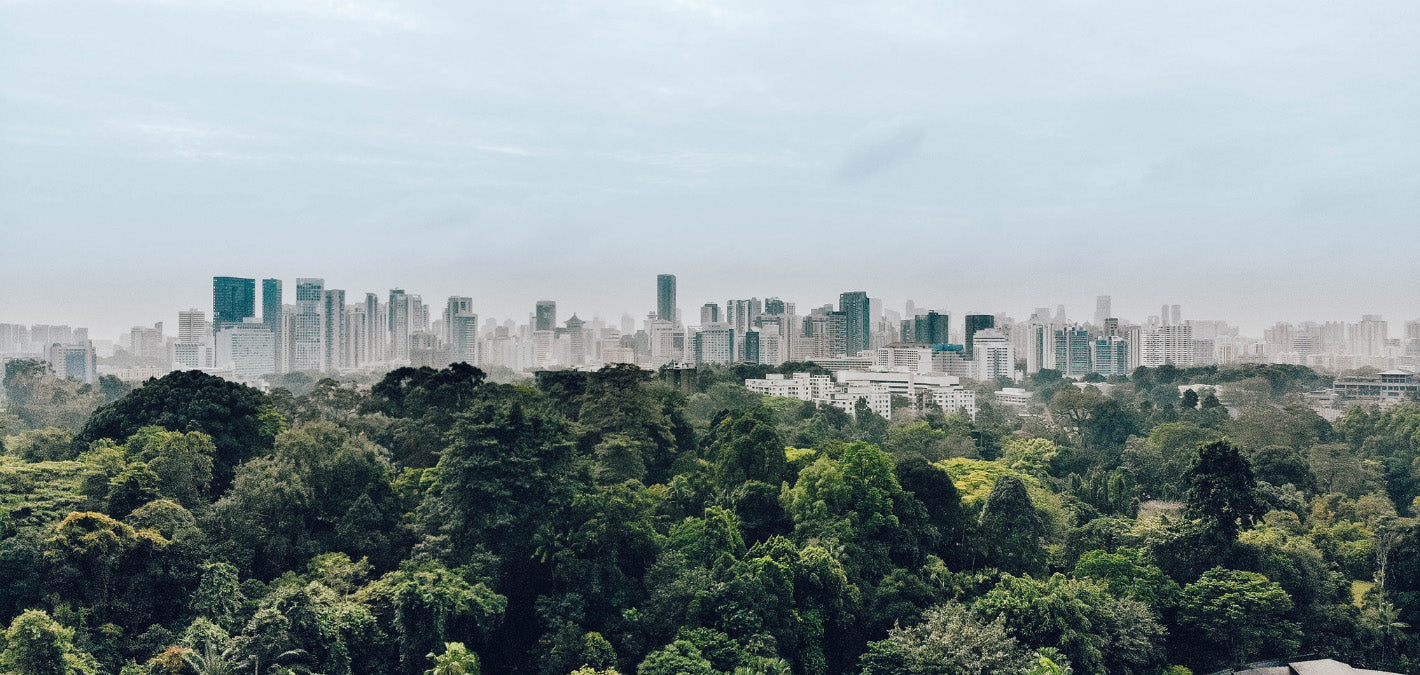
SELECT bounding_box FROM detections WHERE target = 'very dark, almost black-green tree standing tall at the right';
[1184,441,1265,541]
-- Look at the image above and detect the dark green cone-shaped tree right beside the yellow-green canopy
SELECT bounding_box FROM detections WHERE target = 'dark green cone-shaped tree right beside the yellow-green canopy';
[980,475,1045,574]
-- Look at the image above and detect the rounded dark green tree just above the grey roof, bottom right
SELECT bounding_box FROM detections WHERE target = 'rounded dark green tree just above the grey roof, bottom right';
[1179,567,1298,669]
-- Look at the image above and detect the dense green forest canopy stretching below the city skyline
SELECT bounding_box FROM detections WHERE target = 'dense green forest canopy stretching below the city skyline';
[0,362,1420,675]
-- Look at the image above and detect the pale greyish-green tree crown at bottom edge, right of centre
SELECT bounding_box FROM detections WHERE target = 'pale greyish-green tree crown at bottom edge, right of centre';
[859,603,1035,675]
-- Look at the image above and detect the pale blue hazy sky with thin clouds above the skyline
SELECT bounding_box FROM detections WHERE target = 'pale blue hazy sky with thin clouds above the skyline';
[0,0,1420,338]
